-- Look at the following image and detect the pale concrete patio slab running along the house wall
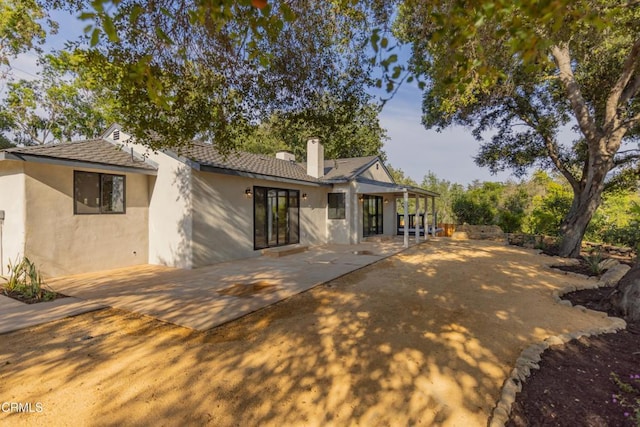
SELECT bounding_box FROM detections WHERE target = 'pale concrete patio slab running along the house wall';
[47,239,416,330]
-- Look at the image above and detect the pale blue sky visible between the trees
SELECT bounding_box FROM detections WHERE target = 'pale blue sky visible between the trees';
[6,8,513,186]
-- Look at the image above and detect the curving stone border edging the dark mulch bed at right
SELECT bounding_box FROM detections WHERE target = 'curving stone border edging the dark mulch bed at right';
[488,273,627,427]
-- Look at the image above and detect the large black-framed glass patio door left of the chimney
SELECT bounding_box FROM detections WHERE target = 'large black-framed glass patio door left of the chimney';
[253,187,300,249]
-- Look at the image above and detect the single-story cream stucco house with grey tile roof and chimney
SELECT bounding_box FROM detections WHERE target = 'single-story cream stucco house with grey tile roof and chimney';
[0,125,437,276]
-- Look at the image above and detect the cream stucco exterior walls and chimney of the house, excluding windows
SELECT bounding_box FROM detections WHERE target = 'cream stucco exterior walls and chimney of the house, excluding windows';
[0,127,438,276]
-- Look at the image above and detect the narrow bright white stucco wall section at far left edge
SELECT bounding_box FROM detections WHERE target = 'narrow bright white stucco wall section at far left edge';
[0,161,25,274]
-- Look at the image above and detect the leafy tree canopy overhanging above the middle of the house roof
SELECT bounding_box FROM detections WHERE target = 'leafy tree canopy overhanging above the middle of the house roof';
[53,0,396,151]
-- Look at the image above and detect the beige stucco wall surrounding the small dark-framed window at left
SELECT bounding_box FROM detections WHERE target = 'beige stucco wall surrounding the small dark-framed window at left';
[24,163,149,276]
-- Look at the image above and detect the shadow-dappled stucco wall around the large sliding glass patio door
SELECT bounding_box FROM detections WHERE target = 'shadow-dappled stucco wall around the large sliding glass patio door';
[193,171,328,267]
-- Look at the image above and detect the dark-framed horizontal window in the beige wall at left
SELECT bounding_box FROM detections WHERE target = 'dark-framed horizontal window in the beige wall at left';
[73,171,125,214]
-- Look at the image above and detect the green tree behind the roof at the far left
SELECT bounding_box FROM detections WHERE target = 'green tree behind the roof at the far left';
[0,52,115,145]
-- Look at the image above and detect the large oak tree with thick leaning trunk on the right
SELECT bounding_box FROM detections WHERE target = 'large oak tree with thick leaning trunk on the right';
[397,0,640,257]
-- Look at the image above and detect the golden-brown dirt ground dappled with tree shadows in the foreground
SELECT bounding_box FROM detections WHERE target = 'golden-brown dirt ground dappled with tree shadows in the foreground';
[0,239,624,426]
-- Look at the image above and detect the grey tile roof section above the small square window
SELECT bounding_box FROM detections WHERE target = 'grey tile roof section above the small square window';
[2,139,157,170]
